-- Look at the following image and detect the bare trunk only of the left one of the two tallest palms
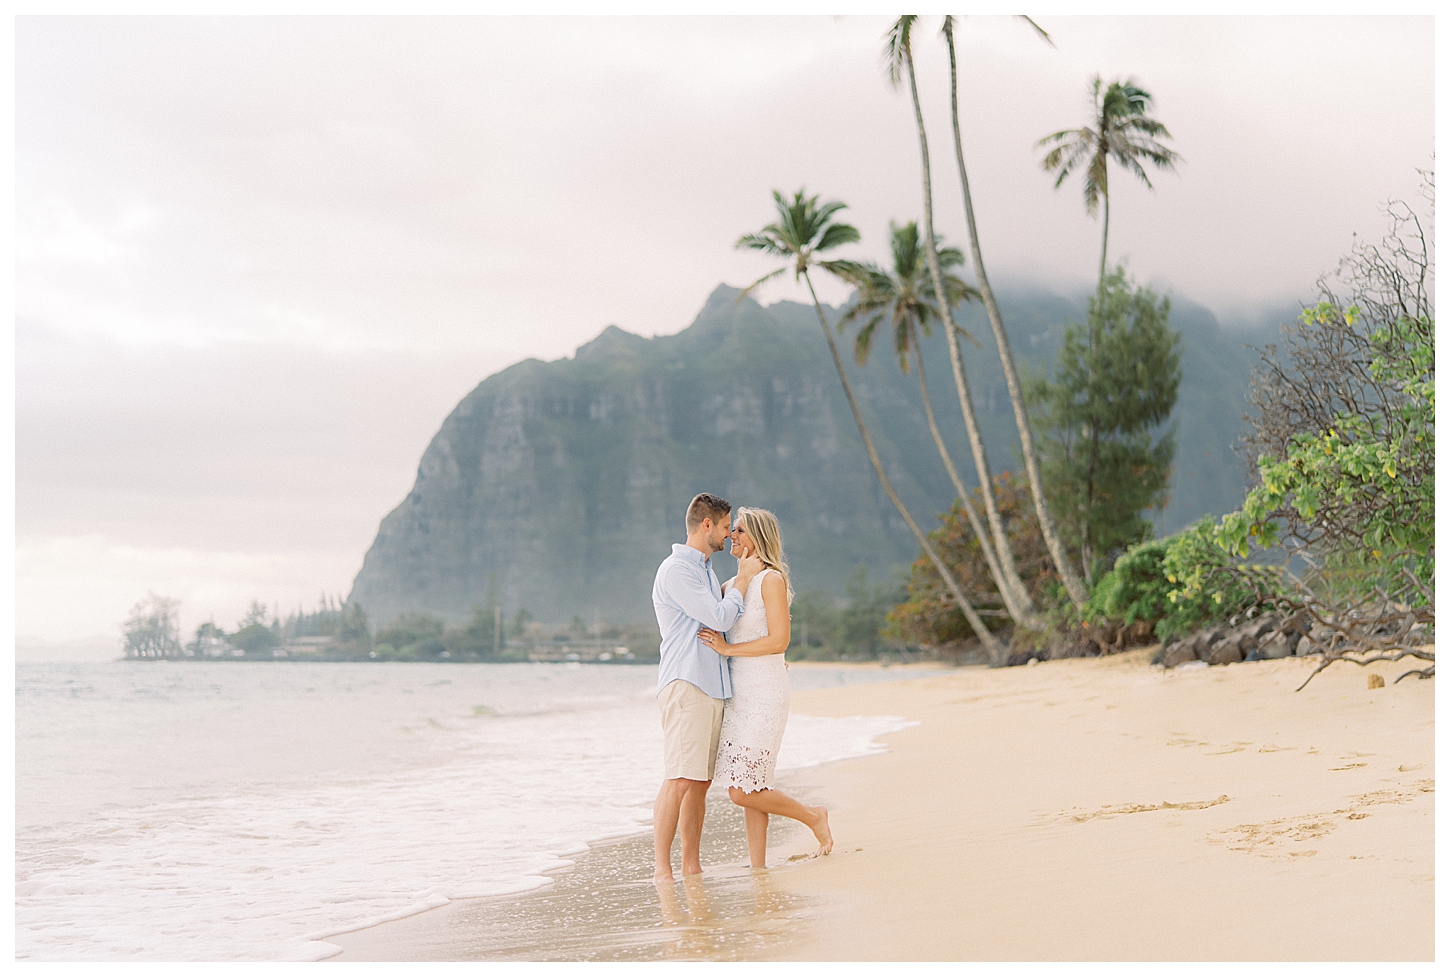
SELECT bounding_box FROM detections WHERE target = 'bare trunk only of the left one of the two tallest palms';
[906,48,1035,623]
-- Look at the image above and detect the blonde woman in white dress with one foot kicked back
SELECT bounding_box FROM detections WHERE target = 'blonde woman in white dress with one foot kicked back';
[700,507,831,868]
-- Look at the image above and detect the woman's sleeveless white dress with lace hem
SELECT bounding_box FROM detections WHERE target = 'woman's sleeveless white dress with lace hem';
[715,570,790,793]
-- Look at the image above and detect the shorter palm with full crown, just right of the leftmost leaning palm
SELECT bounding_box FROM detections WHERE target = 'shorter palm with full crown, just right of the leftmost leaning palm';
[837,222,1034,623]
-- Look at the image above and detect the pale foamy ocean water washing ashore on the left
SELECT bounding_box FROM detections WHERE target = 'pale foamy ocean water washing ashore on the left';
[15,662,908,960]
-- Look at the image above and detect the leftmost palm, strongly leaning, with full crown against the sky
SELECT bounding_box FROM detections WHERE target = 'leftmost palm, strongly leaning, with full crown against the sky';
[735,188,1003,662]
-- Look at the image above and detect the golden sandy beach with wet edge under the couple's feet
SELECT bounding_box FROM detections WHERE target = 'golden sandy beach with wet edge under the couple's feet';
[331,651,1434,961]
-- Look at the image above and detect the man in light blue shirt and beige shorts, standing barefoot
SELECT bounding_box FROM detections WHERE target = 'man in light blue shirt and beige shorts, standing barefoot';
[654,493,766,883]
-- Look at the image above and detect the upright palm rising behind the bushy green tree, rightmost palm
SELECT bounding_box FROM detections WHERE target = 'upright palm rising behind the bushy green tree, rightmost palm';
[1037,75,1180,323]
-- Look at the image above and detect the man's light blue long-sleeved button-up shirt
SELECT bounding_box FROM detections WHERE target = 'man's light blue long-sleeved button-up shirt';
[653,542,745,699]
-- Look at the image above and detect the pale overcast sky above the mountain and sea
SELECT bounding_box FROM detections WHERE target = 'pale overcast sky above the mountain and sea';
[16,16,1434,657]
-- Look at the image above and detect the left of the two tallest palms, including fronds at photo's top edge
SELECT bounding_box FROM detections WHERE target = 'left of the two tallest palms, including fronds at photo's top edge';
[885,14,1049,609]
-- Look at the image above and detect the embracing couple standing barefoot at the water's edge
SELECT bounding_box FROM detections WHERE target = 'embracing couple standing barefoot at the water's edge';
[654,493,831,883]
